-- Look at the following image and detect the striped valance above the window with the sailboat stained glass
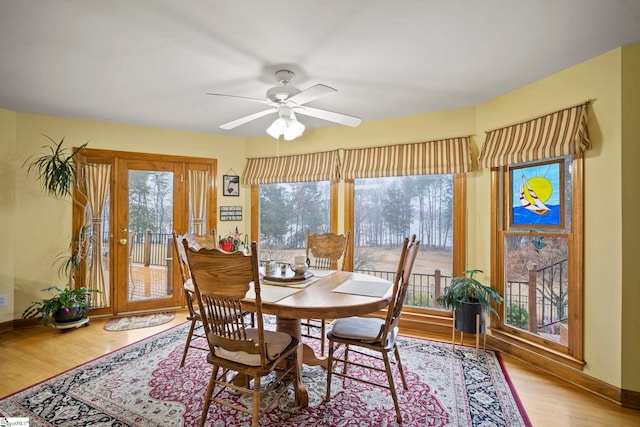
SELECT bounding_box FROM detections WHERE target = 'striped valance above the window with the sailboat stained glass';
[478,102,591,167]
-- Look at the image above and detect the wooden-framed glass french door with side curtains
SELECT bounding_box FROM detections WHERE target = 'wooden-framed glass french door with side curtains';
[74,149,216,315]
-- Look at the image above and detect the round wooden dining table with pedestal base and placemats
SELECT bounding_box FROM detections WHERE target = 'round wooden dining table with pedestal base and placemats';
[243,271,393,406]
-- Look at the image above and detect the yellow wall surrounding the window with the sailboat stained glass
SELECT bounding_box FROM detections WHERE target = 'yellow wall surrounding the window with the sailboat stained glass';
[478,49,628,390]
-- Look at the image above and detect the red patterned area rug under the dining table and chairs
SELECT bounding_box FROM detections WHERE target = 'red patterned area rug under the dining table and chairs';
[0,324,531,427]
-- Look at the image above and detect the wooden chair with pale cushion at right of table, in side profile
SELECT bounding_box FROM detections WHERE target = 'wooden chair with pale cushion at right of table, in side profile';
[325,234,420,423]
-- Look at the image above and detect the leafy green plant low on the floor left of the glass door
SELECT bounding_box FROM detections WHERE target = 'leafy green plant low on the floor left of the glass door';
[22,286,101,326]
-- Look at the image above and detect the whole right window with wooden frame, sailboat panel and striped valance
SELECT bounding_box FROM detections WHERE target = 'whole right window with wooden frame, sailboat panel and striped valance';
[479,103,591,369]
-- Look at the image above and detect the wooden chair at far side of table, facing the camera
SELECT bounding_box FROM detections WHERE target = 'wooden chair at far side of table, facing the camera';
[300,229,351,356]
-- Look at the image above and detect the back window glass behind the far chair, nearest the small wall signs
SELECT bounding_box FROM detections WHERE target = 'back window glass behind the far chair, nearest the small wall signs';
[259,181,330,263]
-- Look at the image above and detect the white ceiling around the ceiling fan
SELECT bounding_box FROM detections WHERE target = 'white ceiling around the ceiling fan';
[0,0,640,138]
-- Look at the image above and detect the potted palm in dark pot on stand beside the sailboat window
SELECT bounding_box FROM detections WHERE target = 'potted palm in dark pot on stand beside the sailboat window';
[438,270,503,334]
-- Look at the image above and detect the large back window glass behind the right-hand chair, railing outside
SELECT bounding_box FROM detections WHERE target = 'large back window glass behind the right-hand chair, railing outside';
[354,175,454,308]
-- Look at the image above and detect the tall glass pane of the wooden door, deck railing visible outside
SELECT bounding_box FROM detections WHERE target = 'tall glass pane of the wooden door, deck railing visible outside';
[128,170,173,301]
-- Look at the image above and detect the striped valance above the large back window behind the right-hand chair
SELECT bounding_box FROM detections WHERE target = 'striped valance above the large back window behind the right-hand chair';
[342,137,471,179]
